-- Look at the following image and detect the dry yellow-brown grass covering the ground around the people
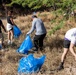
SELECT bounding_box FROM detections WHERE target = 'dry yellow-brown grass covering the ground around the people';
[0,12,76,75]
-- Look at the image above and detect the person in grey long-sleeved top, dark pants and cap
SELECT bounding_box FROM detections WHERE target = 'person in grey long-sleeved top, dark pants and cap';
[27,15,46,51]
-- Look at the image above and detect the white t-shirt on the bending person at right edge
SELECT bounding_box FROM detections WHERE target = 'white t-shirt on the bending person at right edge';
[65,28,76,44]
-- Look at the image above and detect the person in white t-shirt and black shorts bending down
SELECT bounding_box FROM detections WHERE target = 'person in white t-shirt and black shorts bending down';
[58,28,76,70]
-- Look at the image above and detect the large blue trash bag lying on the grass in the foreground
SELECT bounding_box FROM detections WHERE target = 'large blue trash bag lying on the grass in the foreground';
[18,54,46,74]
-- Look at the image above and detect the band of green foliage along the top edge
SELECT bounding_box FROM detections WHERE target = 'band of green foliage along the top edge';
[7,0,76,10]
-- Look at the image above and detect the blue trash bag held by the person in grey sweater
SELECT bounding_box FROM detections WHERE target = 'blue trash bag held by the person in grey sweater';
[17,35,33,54]
